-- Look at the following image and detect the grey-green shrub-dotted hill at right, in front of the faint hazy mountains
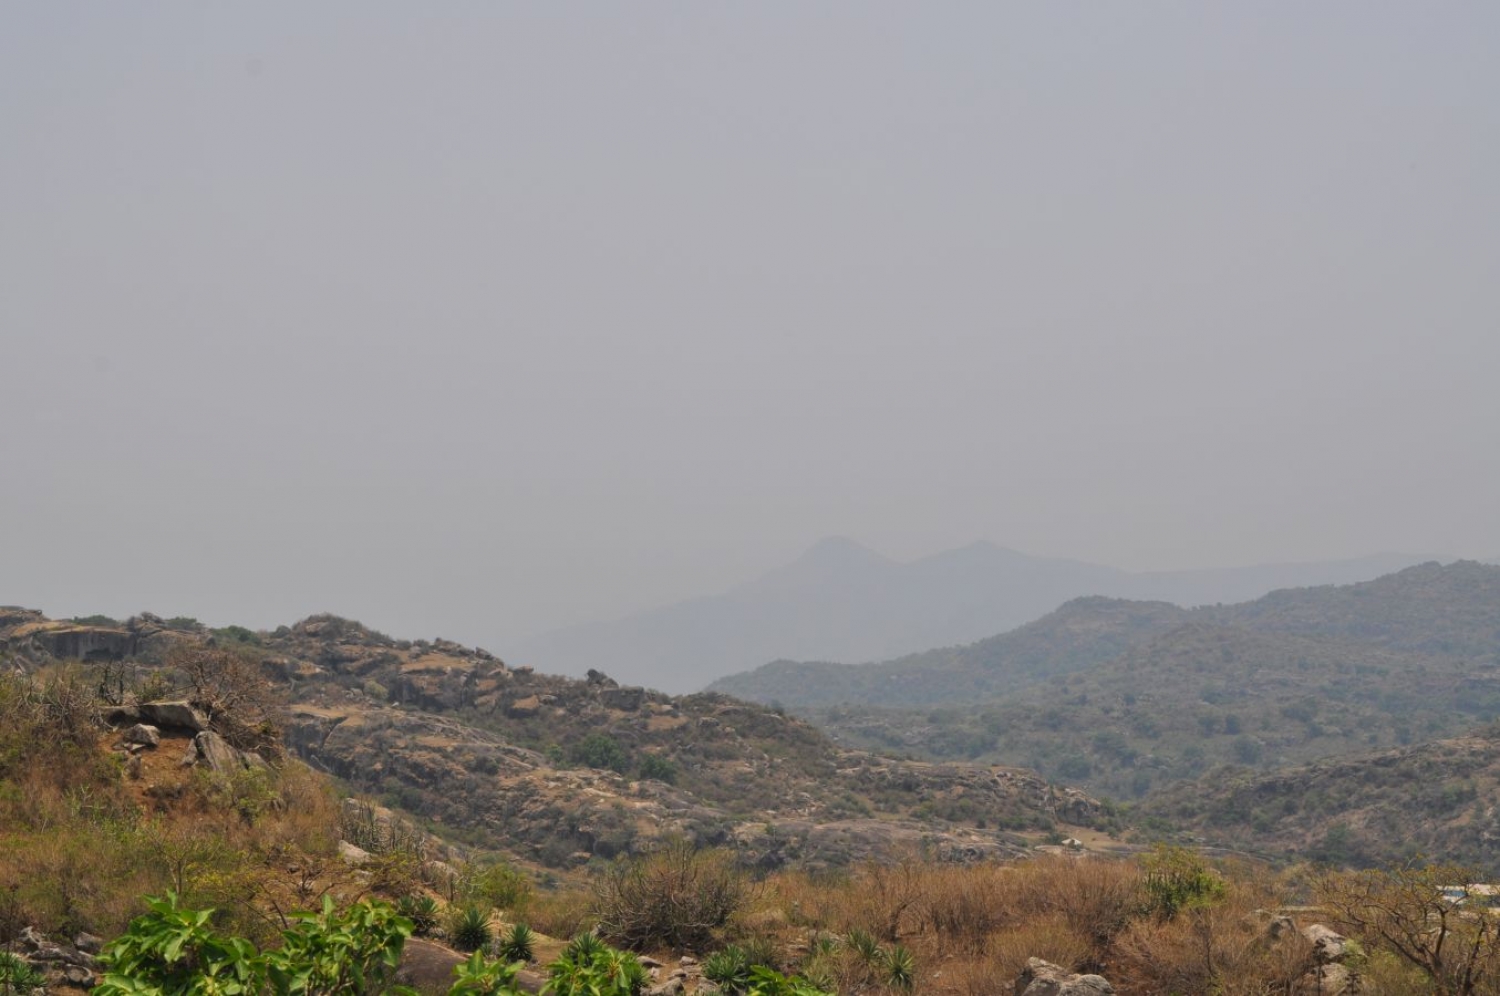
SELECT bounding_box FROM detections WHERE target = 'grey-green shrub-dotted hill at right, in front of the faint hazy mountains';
[716,563,1500,798]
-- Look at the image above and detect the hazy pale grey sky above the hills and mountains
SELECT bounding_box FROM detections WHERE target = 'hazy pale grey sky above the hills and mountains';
[0,0,1500,653]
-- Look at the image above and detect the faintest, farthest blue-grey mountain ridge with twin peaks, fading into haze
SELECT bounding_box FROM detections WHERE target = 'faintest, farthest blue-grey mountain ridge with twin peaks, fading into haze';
[515,537,1430,692]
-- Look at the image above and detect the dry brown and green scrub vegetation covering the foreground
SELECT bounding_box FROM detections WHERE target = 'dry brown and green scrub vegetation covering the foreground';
[0,654,1500,996]
